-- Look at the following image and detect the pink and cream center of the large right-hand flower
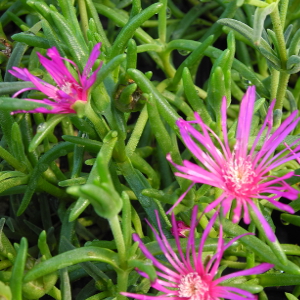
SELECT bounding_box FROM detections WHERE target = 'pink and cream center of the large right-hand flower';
[223,158,257,197]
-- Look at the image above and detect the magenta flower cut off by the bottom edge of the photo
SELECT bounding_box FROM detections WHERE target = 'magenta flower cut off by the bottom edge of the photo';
[121,206,273,300]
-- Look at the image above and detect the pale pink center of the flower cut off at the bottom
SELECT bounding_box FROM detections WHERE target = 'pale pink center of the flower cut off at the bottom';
[178,272,211,300]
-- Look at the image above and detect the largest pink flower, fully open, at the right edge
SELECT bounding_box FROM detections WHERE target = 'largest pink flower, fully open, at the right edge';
[167,86,300,242]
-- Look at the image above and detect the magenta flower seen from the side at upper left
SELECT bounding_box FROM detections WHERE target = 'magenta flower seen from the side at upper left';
[9,43,102,114]
